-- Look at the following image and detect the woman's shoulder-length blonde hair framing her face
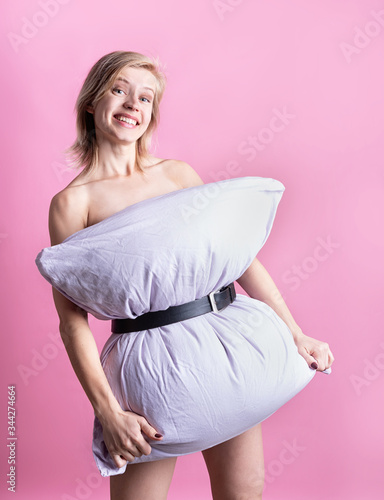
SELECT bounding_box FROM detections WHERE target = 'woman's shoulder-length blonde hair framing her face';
[65,51,166,172]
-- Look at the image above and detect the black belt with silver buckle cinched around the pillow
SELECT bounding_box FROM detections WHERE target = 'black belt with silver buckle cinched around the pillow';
[111,283,236,333]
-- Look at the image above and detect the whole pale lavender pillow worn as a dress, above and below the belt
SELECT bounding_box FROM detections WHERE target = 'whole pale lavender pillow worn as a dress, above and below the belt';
[36,176,316,476]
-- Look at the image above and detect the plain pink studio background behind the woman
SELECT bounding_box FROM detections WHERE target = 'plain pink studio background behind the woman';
[0,0,384,500]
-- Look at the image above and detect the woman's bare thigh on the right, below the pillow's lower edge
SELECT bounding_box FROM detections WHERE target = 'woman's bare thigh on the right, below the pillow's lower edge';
[202,424,264,500]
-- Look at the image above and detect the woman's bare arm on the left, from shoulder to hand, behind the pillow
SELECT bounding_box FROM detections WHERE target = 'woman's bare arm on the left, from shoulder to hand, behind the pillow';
[49,189,162,467]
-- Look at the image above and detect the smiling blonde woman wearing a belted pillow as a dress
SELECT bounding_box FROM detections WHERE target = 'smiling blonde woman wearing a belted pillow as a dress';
[45,51,334,500]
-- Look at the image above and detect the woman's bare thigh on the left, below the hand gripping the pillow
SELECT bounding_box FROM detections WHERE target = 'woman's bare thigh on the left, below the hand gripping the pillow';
[110,457,177,500]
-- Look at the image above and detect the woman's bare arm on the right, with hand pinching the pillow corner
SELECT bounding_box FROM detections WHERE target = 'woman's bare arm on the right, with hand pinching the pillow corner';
[237,258,334,371]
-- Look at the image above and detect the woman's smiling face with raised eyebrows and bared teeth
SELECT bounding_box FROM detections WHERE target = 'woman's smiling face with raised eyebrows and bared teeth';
[88,66,156,144]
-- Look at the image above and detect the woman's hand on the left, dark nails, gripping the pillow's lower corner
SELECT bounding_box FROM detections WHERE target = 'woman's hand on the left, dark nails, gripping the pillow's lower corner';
[99,410,163,468]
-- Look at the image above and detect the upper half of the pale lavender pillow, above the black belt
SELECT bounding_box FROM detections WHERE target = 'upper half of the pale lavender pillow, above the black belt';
[36,177,284,319]
